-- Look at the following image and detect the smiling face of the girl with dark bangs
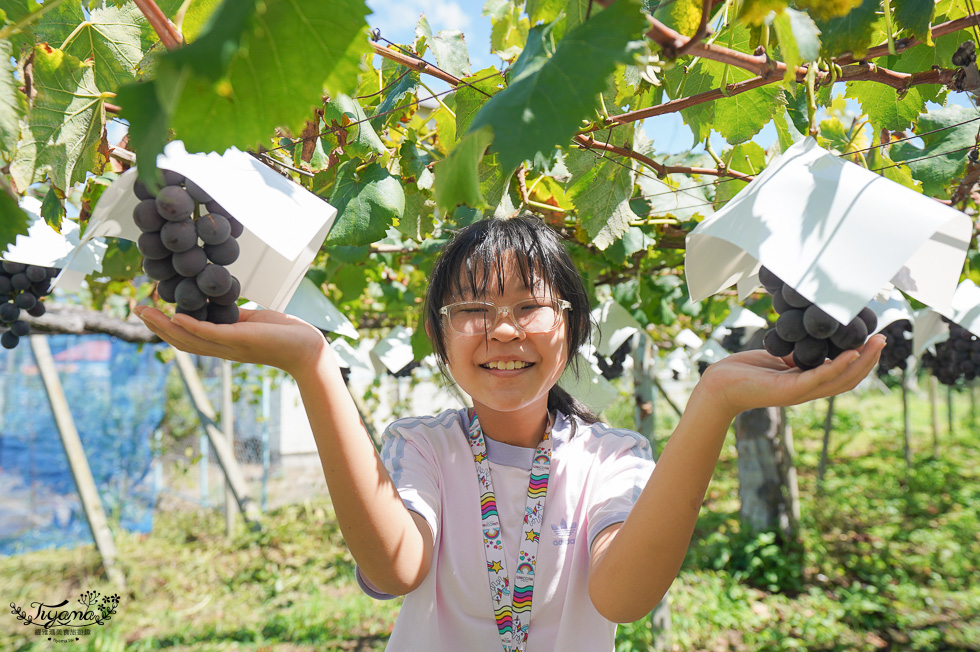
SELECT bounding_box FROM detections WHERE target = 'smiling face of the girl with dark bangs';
[443,254,568,416]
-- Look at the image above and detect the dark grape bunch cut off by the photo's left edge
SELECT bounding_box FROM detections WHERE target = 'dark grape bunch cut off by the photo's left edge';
[0,260,59,349]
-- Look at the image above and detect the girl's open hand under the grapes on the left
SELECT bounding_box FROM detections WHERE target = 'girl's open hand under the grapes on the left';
[133,306,330,376]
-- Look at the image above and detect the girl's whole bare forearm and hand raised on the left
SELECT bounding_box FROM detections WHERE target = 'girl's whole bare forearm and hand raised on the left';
[136,307,432,595]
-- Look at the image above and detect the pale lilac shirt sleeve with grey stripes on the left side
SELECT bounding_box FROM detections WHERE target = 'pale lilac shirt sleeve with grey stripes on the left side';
[355,420,442,600]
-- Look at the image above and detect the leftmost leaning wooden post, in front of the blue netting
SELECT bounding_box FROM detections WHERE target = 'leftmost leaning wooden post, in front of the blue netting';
[30,335,126,589]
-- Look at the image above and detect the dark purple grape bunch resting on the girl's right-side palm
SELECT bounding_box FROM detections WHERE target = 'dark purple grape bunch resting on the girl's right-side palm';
[759,267,878,371]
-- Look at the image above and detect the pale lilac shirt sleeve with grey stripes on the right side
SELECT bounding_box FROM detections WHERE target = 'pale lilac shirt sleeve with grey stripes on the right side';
[588,429,654,549]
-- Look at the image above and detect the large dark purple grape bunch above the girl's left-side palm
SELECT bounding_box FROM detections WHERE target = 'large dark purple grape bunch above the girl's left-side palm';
[133,170,244,324]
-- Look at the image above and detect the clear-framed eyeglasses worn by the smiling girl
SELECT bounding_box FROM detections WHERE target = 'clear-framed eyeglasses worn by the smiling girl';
[439,297,572,335]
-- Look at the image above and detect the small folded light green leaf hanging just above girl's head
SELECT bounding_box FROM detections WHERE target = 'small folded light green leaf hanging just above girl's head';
[433,127,493,212]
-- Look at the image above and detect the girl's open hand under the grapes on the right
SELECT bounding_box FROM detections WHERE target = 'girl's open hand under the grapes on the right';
[698,334,885,415]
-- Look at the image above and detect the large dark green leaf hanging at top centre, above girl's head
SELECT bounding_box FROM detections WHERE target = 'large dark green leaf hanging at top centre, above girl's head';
[470,0,646,171]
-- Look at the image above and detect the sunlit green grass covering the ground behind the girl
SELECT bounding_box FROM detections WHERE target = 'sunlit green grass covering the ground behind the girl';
[0,384,980,652]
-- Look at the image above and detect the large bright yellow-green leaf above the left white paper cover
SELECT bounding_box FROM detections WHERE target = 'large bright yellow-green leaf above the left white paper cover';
[167,0,368,151]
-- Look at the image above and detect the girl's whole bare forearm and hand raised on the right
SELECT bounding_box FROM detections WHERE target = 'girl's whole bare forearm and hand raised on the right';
[589,335,884,623]
